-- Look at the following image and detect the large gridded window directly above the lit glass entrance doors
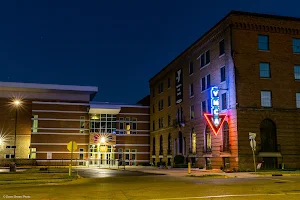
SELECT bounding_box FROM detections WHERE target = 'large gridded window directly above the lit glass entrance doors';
[90,114,116,133]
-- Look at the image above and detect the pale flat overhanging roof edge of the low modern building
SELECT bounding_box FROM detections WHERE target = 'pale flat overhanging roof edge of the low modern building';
[0,82,98,93]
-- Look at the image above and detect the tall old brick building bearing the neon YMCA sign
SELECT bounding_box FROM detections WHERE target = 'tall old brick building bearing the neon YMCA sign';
[149,11,300,170]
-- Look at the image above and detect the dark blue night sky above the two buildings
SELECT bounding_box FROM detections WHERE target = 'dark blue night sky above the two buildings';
[0,0,300,103]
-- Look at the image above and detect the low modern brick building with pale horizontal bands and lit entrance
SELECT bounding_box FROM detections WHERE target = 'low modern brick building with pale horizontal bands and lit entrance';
[0,82,150,166]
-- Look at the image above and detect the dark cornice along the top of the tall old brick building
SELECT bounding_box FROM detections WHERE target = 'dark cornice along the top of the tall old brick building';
[149,10,300,83]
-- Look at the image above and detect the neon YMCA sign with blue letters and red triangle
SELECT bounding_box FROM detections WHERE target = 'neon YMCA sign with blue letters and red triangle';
[204,87,226,135]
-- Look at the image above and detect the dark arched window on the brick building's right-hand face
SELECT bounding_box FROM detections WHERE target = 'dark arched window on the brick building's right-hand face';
[260,119,277,152]
